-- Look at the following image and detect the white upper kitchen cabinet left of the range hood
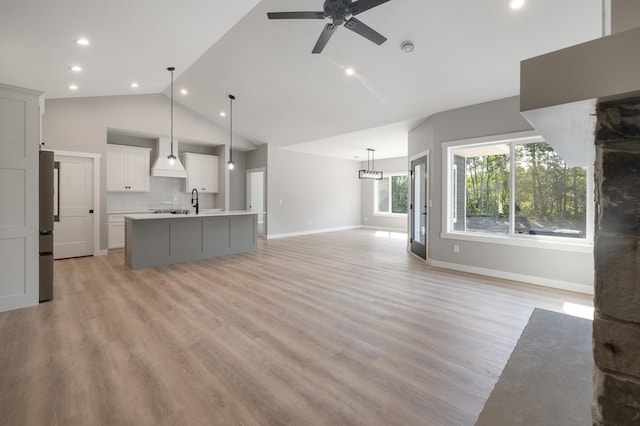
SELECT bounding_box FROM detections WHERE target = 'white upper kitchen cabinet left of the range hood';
[107,145,151,192]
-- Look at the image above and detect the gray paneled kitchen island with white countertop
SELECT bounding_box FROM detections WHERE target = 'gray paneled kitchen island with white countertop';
[124,211,257,269]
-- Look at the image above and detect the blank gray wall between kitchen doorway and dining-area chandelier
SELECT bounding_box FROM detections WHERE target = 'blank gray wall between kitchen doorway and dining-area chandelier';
[267,145,360,238]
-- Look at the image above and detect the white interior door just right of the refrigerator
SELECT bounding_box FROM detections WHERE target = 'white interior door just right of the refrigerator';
[53,155,94,259]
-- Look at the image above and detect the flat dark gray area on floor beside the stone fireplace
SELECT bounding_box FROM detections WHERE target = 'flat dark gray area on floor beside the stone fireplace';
[476,309,593,426]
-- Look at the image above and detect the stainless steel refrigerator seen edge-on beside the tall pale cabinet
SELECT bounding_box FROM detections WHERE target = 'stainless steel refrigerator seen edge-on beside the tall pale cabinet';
[39,151,56,302]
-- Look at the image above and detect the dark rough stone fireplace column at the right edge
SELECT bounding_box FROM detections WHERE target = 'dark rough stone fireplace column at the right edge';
[593,98,640,426]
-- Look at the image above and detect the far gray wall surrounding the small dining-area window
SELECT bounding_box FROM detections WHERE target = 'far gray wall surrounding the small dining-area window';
[360,157,409,232]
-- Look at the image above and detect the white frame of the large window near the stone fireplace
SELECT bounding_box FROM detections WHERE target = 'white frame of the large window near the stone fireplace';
[440,131,595,252]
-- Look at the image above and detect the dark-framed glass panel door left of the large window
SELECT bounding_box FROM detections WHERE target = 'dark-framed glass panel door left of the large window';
[411,156,428,260]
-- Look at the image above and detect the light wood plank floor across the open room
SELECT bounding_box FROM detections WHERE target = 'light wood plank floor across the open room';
[0,230,591,426]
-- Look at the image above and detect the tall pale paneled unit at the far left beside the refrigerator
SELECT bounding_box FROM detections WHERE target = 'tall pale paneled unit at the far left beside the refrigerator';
[0,84,40,312]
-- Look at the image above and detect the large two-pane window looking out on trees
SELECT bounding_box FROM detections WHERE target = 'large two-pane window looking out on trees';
[445,137,591,242]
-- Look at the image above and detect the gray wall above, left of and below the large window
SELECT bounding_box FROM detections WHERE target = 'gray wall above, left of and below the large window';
[409,97,593,292]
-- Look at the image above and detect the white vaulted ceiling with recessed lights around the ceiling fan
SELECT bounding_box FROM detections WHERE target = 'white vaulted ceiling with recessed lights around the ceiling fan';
[0,0,602,159]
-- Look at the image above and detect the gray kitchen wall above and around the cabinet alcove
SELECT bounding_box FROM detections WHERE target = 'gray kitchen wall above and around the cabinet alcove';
[42,95,251,250]
